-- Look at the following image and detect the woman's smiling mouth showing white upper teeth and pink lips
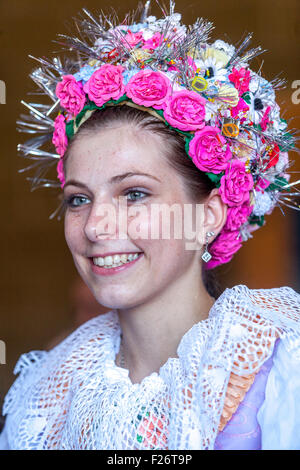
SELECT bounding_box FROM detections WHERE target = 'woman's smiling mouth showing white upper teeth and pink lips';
[90,252,143,275]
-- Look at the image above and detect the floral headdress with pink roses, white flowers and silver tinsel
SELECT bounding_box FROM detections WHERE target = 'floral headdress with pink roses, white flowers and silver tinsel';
[18,1,300,269]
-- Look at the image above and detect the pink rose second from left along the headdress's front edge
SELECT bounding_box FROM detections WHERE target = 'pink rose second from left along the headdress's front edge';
[83,64,125,107]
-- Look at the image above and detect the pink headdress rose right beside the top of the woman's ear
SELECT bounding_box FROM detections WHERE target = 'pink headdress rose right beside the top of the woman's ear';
[219,160,253,206]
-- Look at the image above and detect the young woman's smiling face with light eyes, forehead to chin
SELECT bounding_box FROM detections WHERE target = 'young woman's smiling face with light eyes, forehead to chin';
[64,124,204,309]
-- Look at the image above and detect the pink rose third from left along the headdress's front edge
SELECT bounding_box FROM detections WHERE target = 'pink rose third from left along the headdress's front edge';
[126,70,172,109]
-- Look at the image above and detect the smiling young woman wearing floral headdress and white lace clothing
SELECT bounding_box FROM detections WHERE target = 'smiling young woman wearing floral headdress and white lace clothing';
[0,3,300,449]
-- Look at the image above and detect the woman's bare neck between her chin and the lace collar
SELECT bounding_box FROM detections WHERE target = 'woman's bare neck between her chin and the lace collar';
[117,274,215,383]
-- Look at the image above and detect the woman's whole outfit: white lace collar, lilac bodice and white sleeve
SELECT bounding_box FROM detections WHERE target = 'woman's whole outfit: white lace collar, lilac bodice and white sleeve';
[0,285,300,450]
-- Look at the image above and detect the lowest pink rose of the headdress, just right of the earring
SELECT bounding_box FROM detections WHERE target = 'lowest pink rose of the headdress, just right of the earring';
[205,228,242,269]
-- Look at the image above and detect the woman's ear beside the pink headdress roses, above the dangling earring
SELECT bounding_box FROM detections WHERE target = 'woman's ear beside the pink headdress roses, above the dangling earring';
[198,188,228,245]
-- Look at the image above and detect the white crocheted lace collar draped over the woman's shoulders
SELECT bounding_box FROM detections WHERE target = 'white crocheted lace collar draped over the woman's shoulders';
[3,285,300,449]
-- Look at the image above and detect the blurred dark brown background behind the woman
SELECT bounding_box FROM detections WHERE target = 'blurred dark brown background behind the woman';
[0,0,300,414]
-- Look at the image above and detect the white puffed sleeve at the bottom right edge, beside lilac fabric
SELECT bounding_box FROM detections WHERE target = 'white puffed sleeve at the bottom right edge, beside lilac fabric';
[257,341,300,450]
